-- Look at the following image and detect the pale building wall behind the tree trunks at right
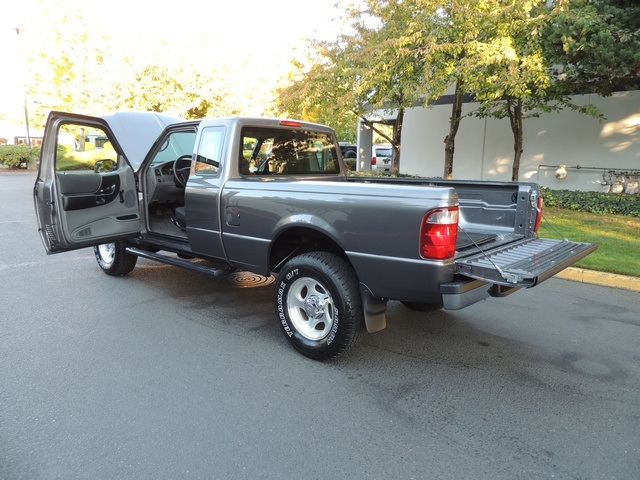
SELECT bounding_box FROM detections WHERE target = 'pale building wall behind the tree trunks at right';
[400,91,640,191]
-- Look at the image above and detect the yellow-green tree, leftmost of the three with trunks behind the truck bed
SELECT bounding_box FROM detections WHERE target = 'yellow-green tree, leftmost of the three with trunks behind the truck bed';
[279,0,446,173]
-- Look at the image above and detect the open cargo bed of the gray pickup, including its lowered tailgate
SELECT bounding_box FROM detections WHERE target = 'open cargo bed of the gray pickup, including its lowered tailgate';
[348,178,597,288]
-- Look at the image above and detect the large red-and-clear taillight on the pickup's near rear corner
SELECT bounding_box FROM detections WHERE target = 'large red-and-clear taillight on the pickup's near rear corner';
[420,207,458,260]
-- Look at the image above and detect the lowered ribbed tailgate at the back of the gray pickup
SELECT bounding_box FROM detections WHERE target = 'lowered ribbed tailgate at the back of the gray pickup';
[455,238,598,288]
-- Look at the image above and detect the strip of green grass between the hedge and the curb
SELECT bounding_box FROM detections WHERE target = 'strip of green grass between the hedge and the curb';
[538,207,640,277]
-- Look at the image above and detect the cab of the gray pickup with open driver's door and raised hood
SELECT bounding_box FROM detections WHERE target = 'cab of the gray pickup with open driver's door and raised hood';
[34,112,343,269]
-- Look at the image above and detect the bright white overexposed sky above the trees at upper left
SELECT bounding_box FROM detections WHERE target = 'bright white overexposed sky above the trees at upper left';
[0,0,348,124]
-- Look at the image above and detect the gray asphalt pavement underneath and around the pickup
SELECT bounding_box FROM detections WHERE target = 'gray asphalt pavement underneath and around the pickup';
[0,173,640,480]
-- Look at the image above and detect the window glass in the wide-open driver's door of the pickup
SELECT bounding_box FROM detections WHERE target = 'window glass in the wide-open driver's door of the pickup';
[55,123,119,173]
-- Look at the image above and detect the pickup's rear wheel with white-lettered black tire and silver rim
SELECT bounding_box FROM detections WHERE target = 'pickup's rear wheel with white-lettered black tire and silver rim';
[275,252,364,361]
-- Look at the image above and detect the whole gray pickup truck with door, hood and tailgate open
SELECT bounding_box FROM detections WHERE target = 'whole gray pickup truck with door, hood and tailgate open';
[34,112,596,360]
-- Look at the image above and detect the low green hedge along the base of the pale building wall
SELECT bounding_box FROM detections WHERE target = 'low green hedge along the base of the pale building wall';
[542,188,640,217]
